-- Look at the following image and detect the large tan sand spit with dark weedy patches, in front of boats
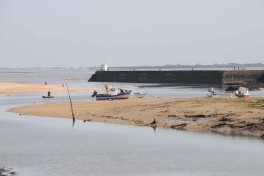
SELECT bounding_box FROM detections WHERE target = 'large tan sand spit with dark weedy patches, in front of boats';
[9,98,264,137]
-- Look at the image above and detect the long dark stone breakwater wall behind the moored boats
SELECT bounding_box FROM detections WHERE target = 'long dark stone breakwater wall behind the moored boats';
[89,70,264,84]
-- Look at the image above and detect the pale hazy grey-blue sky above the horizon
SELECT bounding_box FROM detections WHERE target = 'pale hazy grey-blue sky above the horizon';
[0,0,264,68]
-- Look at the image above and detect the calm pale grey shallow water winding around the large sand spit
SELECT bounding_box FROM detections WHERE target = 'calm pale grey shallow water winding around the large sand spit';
[0,68,264,176]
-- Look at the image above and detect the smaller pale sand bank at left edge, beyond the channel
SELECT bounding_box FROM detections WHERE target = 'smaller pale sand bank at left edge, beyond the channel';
[0,82,101,94]
